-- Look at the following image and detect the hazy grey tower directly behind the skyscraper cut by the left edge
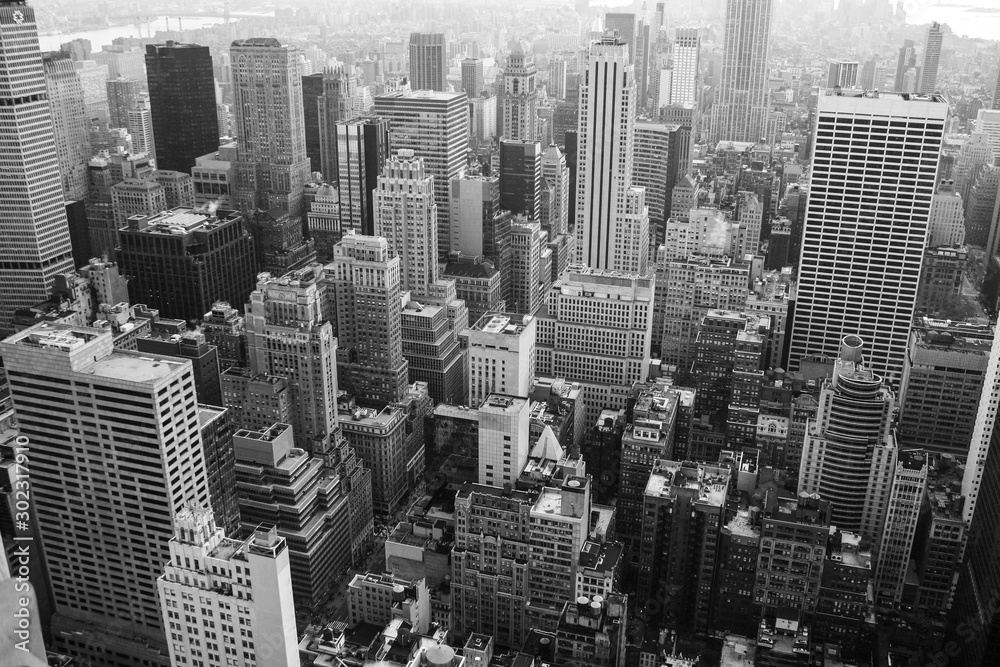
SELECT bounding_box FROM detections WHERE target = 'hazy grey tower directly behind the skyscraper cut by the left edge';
[42,53,91,202]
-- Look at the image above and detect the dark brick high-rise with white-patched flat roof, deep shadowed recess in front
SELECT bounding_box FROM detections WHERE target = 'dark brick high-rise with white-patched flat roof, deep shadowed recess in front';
[638,459,730,632]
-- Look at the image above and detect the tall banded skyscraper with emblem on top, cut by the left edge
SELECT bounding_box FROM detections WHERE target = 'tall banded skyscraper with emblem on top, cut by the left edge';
[0,0,73,332]
